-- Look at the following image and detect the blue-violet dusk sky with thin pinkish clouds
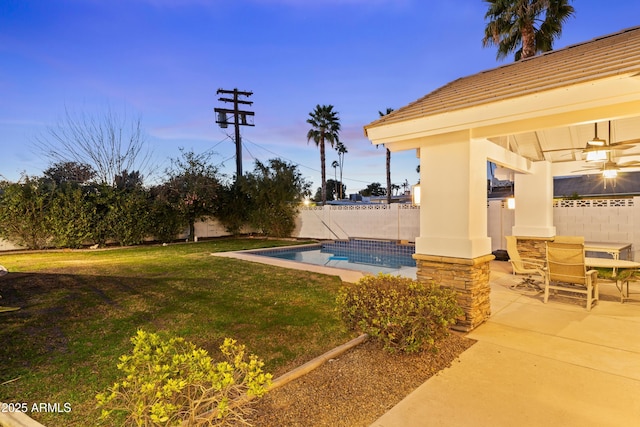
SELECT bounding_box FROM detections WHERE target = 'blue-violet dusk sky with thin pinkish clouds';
[0,0,640,193]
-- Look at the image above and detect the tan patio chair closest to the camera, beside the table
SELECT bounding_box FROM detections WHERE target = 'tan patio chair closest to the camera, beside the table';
[544,242,599,311]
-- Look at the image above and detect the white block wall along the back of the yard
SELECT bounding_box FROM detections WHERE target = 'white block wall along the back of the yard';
[0,197,640,259]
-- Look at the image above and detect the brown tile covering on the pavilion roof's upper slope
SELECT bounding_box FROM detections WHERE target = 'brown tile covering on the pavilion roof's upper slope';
[365,26,640,132]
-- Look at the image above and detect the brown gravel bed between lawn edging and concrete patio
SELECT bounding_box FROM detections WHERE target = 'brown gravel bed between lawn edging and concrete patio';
[250,333,475,427]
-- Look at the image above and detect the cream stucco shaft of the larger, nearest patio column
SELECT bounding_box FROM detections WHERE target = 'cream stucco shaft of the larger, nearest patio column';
[416,132,491,259]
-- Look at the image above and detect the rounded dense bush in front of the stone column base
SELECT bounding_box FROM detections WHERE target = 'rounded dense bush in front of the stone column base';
[337,274,463,353]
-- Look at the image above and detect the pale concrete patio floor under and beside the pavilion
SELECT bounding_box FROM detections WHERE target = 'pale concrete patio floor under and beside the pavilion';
[371,261,640,427]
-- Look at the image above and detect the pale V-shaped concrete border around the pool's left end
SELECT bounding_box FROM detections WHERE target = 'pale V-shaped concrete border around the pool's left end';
[211,243,364,283]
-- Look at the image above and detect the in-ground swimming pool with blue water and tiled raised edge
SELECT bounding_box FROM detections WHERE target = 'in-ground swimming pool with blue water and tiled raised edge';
[252,239,417,279]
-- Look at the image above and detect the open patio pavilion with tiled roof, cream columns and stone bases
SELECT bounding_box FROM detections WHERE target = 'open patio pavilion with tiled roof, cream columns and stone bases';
[365,27,640,331]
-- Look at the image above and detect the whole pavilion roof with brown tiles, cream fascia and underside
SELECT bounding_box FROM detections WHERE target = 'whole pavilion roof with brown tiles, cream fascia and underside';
[365,27,640,175]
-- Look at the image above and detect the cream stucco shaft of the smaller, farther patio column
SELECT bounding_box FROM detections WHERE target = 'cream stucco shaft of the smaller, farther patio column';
[512,162,556,237]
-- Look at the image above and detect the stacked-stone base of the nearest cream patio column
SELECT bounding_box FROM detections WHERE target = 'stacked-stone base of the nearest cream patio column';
[413,254,495,332]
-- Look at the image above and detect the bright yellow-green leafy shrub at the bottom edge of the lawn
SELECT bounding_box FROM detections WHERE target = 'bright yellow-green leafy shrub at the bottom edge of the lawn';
[96,330,271,426]
